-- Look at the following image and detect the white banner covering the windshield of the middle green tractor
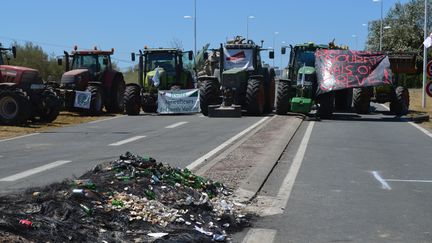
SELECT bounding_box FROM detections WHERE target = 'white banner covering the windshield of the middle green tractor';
[224,48,254,70]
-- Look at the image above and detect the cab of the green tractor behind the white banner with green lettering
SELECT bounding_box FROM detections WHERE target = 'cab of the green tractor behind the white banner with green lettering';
[132,48,193,90]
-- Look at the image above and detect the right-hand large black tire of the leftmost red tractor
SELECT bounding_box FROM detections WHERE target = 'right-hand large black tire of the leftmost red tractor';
[39,90,61,123]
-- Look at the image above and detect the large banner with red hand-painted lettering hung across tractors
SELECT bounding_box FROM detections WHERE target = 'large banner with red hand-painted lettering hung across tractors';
[315,49,392,94]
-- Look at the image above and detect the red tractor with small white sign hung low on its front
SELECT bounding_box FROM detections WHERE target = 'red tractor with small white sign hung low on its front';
[54,46,126,115]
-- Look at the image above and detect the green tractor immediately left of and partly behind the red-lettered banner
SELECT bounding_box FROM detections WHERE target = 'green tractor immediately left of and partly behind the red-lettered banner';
[276,42,352,118]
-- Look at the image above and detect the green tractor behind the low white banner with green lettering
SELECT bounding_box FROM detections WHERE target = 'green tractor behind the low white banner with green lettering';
[124,47,194,115]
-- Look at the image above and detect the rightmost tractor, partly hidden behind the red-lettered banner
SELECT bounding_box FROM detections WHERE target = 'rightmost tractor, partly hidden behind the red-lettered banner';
[353,53,417,115]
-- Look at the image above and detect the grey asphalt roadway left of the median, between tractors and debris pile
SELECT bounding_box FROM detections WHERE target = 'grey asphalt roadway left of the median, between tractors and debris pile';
[0,112,262,192]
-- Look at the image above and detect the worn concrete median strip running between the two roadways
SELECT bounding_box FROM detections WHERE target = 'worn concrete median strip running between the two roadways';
[198,116,303,201]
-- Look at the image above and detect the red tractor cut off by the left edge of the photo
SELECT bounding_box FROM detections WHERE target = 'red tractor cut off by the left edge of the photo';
[0,44,61,125]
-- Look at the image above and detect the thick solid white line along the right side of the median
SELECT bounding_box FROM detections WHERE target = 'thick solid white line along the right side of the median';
[264,121,315,216]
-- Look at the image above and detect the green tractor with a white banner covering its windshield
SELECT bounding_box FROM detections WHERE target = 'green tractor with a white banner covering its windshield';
[198,36,275,117]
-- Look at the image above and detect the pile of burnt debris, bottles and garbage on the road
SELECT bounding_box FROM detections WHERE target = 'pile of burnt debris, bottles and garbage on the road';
[0,152,250,242]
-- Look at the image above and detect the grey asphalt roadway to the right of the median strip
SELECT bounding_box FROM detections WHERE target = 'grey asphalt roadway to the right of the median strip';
[235,105,432,242]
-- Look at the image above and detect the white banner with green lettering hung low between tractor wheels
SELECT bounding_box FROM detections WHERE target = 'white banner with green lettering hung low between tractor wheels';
[157,89,200,114]
